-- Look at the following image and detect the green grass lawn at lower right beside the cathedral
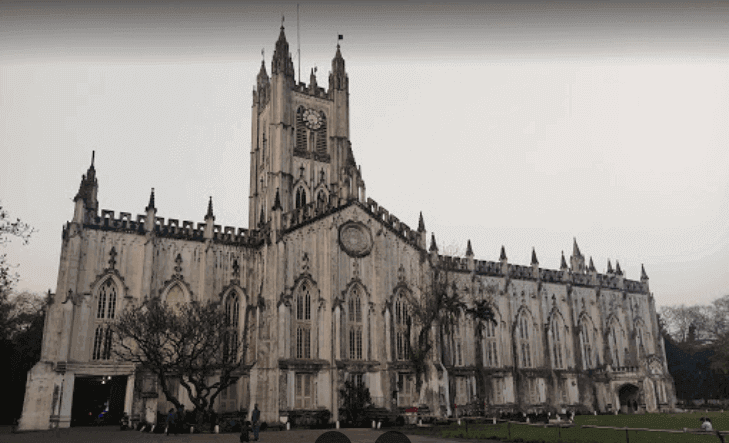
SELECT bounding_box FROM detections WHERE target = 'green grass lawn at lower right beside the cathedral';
[431,412,729,443]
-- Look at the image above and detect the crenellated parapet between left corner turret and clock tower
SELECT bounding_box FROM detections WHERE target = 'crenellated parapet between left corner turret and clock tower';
[79,209,260,246]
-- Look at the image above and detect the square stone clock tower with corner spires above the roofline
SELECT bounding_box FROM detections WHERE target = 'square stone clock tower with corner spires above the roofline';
[249,26,365,229]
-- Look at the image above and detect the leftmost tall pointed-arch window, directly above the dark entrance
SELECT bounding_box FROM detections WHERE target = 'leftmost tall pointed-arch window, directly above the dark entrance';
[90,271,126,361]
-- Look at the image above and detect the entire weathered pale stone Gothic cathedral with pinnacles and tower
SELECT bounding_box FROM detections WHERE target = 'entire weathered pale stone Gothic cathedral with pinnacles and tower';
[20,27,675,430]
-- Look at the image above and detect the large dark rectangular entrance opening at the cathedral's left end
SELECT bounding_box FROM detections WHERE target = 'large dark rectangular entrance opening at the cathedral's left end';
[71,376,127,426]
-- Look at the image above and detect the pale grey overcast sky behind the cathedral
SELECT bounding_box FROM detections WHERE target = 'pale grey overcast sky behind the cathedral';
[0,2,729,306]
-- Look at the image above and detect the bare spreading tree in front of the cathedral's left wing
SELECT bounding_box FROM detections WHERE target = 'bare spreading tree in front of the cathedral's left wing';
[114,298,248,420]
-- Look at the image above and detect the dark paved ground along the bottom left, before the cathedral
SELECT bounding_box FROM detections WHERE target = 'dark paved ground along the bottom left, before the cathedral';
[0,426,494,443]
